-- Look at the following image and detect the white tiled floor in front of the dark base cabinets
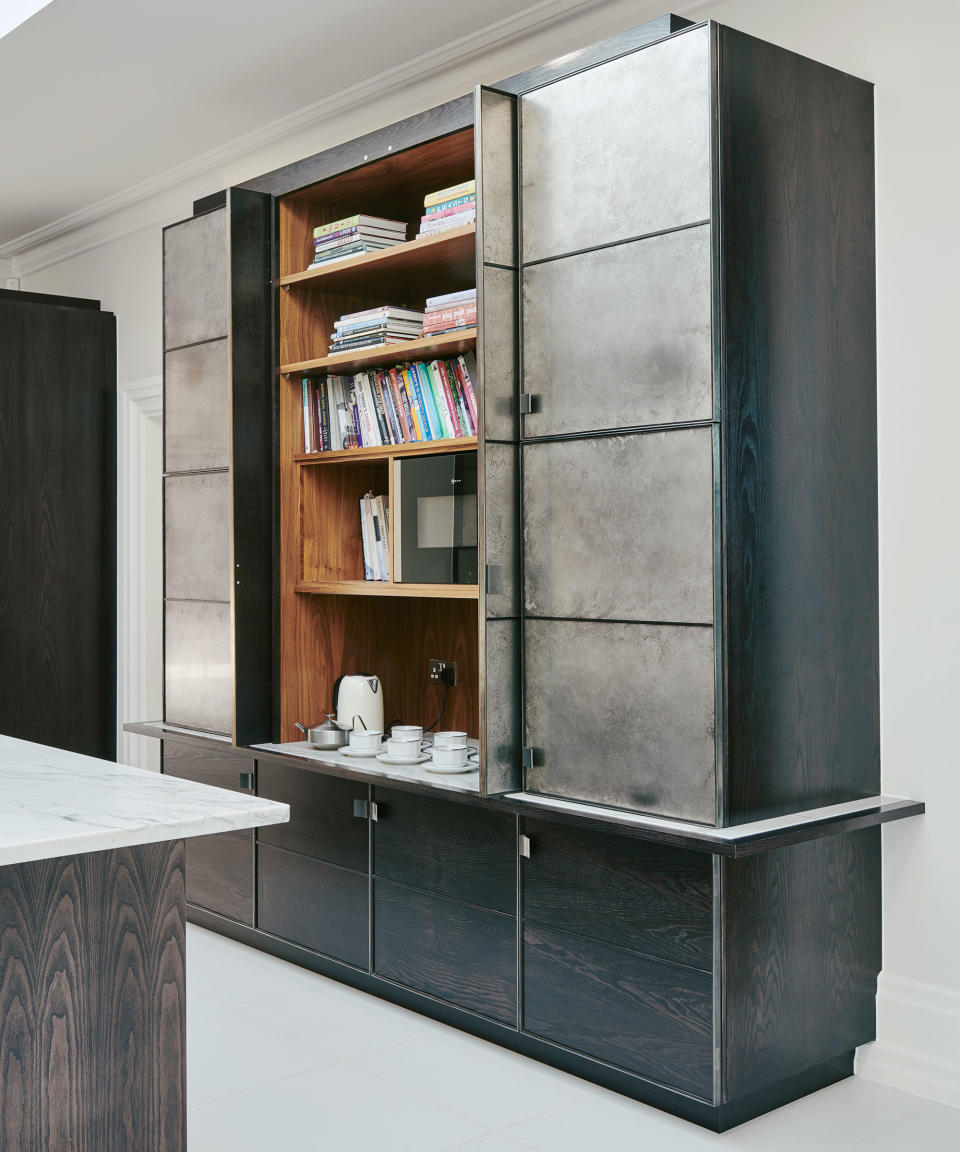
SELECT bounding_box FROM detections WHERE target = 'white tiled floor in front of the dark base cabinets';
[187,926,960,1152]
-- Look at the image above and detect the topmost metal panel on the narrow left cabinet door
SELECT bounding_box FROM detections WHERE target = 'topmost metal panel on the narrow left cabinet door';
[164,209,229,349]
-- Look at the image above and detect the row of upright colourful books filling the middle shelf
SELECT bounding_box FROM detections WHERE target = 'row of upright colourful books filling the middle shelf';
[302,353,478,453]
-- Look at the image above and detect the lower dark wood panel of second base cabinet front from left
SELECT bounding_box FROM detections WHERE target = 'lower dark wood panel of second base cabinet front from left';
[257,844,370,970]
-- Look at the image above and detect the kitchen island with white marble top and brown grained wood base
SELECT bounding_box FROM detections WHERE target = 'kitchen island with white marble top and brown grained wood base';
[0,736,289,1152]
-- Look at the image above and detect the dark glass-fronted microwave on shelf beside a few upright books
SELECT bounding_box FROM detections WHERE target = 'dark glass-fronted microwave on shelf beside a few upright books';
[393,452,478,584]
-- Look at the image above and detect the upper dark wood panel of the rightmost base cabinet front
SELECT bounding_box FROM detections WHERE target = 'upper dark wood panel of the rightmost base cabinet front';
[523,820,713,971]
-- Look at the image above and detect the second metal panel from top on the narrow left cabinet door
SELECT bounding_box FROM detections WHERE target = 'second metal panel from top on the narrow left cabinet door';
[164,340,230,472]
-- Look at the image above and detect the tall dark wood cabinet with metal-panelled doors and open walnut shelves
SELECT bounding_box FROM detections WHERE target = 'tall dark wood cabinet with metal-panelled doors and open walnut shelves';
[136,16,923,1130]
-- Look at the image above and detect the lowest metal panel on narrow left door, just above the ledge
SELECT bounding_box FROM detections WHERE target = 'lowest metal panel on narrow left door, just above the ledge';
[164,600,233,735]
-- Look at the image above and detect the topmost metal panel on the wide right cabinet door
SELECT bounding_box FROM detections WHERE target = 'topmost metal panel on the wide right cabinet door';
[520,26,711,262]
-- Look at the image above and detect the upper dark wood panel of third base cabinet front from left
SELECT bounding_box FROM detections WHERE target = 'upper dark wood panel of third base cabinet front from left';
[373,788,516,916]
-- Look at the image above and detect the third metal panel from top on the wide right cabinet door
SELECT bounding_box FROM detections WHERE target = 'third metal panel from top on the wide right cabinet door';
[523,427,713,623]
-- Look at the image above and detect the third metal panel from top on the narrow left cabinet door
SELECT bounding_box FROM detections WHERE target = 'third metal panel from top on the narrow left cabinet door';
[164,472,230,601]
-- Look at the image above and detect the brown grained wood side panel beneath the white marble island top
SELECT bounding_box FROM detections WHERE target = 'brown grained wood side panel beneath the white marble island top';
[0,841,187,1152]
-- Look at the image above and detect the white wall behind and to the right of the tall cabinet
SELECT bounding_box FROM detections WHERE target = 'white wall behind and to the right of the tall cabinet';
[15,0,960,1105]
